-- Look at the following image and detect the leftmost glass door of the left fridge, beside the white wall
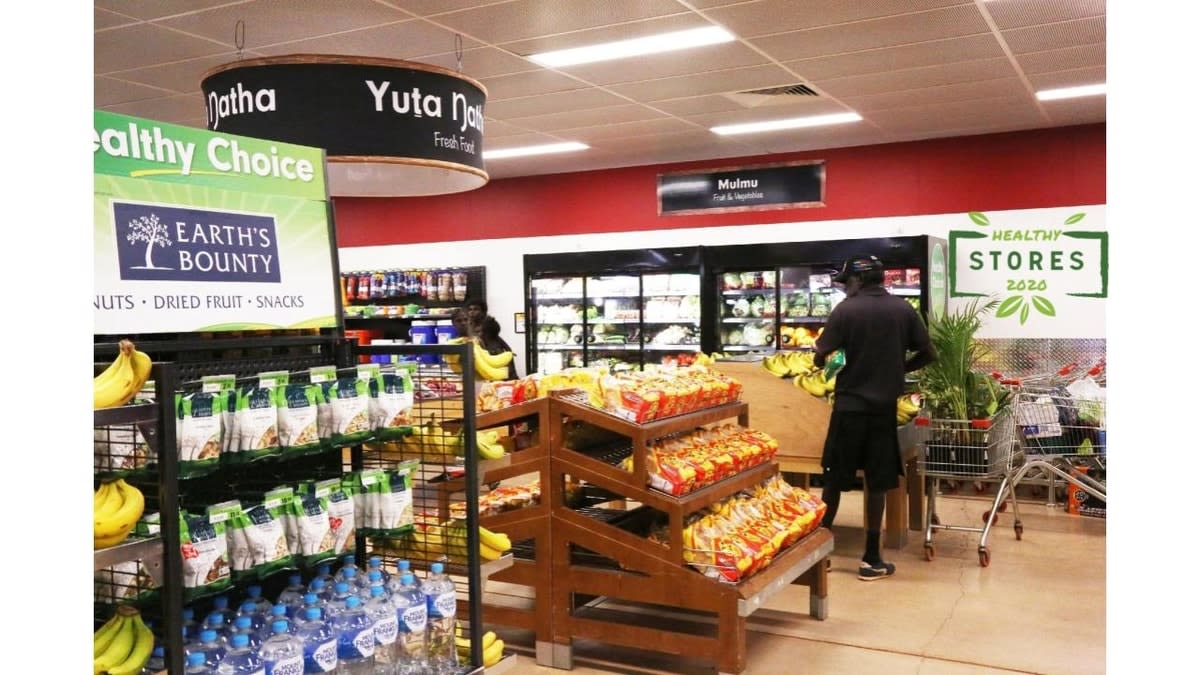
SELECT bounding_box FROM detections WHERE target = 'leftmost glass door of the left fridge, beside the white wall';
[530,276,586,374]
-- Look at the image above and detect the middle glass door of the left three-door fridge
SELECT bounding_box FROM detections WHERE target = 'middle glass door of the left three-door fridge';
[585,275,642,371]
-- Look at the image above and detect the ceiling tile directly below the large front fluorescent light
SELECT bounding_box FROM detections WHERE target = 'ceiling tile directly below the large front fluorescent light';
[547,42,767,84]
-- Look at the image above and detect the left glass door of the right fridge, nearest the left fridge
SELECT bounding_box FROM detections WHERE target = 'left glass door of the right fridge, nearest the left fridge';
[716,269,778,352]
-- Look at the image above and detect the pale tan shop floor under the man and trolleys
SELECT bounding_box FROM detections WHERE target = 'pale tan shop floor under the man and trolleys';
[482,494,1105,675]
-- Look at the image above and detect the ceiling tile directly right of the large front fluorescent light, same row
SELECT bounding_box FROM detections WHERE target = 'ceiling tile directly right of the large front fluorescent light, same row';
[751,5,990,61]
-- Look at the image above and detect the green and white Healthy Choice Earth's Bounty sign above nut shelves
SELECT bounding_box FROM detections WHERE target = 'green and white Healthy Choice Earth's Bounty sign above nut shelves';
[92,112,337,335]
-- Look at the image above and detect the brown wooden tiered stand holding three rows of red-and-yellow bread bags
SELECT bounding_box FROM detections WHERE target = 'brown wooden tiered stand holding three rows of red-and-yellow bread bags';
[536,393,833,673]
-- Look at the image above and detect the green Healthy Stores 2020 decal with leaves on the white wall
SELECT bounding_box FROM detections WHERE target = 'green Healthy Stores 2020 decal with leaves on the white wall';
[949,211,1109,324]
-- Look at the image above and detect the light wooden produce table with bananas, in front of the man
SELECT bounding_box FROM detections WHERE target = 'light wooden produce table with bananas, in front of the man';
[710,359,924,549]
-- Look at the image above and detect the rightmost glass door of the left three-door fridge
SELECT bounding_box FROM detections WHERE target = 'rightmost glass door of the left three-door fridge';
[642,274,700,365]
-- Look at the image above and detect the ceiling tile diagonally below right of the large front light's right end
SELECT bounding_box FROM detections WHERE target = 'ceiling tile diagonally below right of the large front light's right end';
[784,34,1004,80]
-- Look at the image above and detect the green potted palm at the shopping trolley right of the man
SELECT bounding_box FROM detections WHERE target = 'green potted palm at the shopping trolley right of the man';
[918,299,1010,473]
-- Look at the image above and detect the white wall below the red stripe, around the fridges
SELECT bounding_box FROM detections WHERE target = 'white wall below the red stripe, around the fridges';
[338,204,1106,372]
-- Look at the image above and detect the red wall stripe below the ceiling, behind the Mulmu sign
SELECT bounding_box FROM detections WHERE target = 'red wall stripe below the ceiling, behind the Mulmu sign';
[334,124,1105,246]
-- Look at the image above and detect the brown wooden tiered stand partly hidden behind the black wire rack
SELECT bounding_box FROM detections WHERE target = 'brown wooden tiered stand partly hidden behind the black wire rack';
[475,398,552,641]
